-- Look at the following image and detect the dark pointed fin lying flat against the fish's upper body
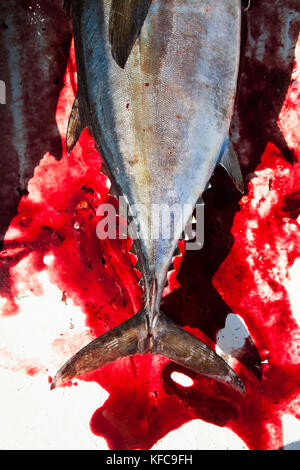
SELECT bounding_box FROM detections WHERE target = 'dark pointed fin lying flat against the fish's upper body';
[109,0,151,69]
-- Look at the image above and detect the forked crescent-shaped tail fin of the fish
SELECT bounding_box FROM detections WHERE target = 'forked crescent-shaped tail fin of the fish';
[51,310,245,393]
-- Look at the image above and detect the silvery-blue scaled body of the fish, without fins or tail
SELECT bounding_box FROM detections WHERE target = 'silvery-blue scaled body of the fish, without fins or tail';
[73,0,241,306]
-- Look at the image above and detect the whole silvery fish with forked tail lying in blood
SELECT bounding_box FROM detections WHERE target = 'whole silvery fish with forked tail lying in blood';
[51,0,245,394]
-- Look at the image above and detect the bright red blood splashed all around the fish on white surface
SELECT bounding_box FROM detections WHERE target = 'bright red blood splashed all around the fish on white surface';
[0,1,300,449]
